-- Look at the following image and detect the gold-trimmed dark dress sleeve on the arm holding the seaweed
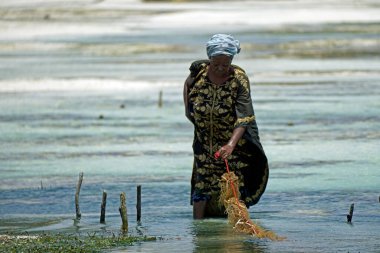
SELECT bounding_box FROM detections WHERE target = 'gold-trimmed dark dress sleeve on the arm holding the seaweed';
[234,71,255,128]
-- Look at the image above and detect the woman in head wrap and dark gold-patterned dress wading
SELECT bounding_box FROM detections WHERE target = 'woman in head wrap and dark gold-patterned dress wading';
[183,34,269,219]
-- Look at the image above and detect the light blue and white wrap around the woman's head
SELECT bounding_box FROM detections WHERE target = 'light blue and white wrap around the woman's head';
[206,34,240,58]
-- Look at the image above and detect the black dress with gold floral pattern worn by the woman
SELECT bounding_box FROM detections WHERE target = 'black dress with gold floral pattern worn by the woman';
[188,60,269,214]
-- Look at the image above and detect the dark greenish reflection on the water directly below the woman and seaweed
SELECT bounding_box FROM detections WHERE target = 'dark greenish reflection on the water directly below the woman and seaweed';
[191,219,266,253]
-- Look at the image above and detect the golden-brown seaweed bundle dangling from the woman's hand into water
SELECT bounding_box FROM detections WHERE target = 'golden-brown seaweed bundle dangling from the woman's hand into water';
[219,172,284,240]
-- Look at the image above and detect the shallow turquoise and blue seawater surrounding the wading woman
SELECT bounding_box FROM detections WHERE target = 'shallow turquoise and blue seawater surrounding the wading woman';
[0,1,380,252]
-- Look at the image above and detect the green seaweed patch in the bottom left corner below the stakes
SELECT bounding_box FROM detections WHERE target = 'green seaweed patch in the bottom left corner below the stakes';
[0,233,156,253]
